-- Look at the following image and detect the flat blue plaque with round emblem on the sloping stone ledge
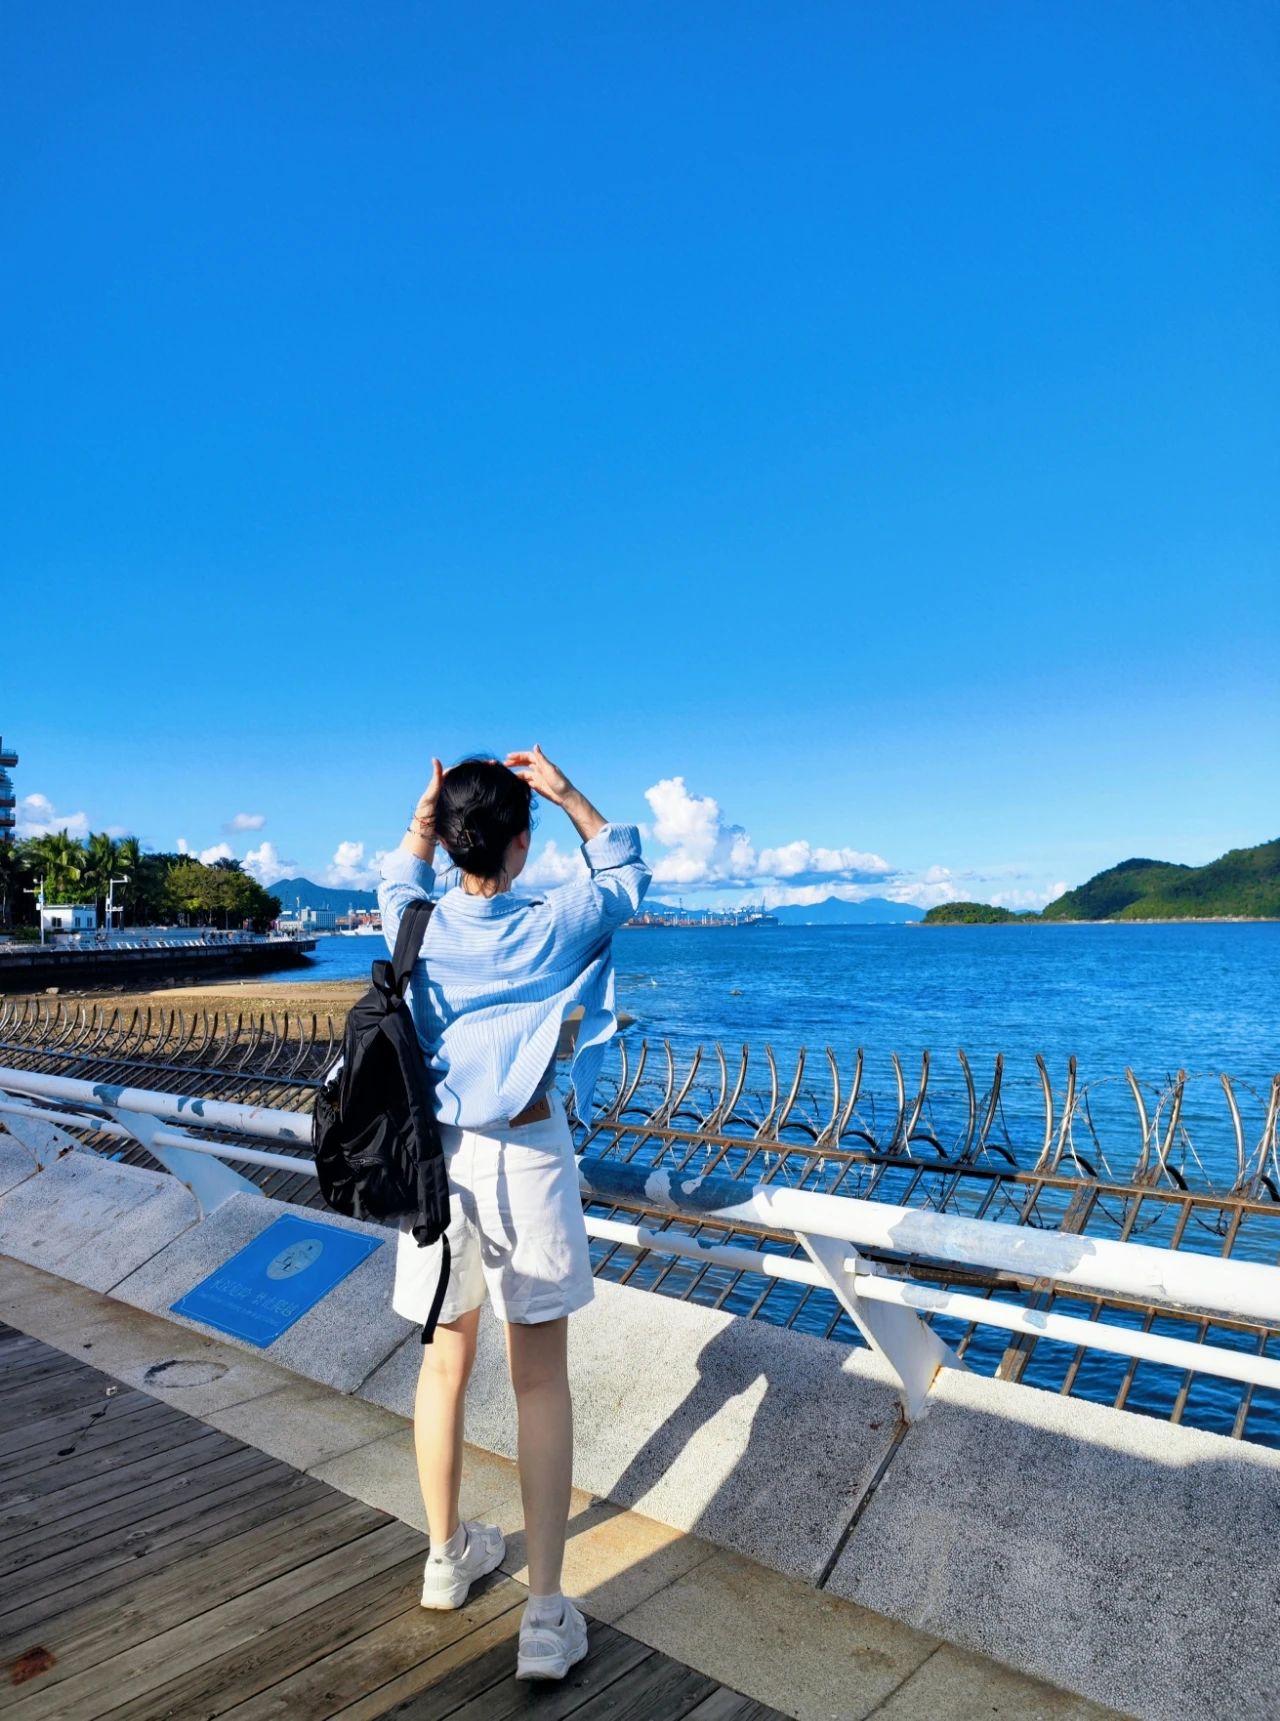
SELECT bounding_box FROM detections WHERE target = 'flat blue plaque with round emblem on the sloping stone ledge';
[172,1213,382,1346]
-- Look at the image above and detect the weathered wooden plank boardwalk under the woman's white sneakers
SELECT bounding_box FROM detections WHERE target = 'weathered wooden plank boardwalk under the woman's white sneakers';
[0,1325,778,1721]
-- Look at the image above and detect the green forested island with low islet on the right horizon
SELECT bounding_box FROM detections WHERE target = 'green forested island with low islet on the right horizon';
[920,838,1280,926]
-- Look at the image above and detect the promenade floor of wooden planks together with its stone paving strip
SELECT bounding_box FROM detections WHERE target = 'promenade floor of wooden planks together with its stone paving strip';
[0,1258,1111,1721]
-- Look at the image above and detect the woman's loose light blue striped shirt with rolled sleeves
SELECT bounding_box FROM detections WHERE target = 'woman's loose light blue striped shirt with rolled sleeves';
[378,824,650,1129]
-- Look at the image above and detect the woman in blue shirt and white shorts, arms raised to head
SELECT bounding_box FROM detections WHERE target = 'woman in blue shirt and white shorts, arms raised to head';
[378,747,649,1680]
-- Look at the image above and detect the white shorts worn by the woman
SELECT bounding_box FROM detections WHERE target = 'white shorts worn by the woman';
[391,1093,595,1325]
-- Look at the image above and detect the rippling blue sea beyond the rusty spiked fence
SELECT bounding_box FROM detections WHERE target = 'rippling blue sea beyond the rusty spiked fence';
[264,924,1280,1186]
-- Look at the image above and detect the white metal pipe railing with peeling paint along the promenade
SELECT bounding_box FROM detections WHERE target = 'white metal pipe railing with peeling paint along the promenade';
[0,1069,1280,1418]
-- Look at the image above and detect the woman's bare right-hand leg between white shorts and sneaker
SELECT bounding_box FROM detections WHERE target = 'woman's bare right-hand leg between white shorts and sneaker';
[508,1317,573,1595]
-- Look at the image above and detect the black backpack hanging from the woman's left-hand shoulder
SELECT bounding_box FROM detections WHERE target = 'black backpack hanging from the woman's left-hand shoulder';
[311,902,449,1344]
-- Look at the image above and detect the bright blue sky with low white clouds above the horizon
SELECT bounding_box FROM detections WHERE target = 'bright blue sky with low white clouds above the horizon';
[0,0,1280,905]
